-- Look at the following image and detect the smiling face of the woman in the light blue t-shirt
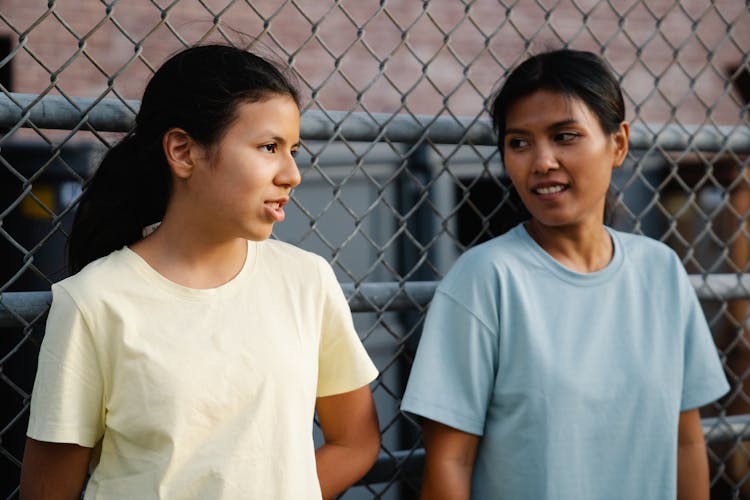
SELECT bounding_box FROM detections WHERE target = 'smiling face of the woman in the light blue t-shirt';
[503,90,628,234]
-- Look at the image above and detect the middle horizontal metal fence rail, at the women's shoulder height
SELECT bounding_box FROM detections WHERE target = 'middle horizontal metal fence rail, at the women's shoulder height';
[0,274,750,328]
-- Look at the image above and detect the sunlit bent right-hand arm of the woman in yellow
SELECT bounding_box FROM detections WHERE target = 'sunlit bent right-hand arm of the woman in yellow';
[315,386,380,499]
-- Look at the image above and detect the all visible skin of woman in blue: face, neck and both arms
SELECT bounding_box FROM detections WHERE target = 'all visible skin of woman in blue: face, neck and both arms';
[422,90,709,500]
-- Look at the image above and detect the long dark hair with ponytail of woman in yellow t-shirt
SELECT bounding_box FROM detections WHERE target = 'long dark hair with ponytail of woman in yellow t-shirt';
[68,45,299,273]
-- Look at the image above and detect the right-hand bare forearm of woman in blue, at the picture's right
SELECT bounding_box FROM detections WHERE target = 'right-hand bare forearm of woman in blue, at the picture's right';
[677,409,709,500]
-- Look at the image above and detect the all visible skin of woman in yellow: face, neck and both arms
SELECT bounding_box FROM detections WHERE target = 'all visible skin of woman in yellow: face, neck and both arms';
[21,95,380,500]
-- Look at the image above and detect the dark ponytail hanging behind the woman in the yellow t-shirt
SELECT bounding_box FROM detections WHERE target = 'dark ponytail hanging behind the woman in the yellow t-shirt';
[68,133,170,274]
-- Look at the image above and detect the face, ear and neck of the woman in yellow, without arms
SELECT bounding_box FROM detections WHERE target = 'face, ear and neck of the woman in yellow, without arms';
[131,96,301,288]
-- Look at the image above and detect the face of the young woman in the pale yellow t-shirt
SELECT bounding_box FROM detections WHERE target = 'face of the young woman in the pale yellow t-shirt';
[185,95,301,241]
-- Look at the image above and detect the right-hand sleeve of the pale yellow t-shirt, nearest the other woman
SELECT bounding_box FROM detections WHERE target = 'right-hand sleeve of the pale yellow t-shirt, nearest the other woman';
[317,262,378,397]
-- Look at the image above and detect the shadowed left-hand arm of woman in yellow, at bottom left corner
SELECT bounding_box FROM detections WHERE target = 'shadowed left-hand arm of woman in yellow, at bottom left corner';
[20,438,91,500]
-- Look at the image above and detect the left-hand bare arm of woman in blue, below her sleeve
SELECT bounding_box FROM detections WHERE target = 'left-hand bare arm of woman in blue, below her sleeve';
[422,419,479,500]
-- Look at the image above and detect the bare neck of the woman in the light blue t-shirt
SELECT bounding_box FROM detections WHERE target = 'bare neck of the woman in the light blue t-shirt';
[525,219,614,273]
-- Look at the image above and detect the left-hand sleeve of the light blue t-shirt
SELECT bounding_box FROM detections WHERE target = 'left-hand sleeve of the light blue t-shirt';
[401,289,498,435]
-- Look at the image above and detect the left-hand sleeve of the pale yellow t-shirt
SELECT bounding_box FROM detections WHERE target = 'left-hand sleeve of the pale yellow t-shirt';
[27,285,104,447]
